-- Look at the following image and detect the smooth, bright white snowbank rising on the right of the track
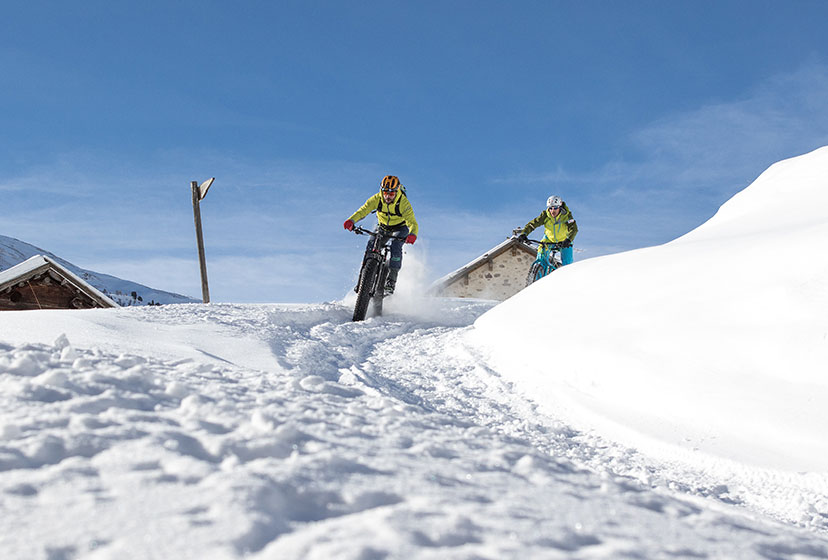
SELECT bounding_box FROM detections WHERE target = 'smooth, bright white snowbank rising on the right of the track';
[474,148,828,516]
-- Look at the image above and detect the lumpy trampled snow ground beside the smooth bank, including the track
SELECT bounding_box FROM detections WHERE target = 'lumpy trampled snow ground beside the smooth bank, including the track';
[0,301,828,559]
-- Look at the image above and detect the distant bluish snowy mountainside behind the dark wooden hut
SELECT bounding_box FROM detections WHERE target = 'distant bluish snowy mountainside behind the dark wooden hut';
[0,235,198,306]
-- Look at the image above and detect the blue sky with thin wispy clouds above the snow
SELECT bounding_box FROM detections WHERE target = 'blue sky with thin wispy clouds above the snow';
[0,1,828,302]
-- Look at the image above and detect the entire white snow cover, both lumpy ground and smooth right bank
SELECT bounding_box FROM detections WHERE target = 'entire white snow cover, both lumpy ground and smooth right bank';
[0,149,828,559]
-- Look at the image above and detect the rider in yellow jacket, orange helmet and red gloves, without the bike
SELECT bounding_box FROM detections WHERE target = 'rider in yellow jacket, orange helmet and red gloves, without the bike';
[343,175,419,295]
